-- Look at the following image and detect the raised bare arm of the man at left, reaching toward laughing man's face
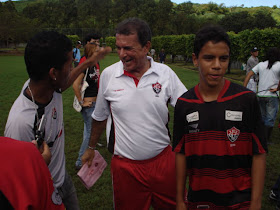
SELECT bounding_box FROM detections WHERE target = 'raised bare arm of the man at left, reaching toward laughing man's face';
[61,47,112,91]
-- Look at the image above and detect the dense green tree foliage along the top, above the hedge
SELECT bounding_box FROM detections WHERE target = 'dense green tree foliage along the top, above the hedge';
[0,0,280,48]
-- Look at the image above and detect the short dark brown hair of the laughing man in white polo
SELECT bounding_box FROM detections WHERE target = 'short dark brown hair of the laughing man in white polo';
[116,18,152,47]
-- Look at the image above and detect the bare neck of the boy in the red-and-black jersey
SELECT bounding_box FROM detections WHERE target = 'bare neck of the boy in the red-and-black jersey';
[198,80,225,102]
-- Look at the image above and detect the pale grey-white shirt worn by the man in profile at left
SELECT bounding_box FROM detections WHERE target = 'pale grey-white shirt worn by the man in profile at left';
[4,79,65,188]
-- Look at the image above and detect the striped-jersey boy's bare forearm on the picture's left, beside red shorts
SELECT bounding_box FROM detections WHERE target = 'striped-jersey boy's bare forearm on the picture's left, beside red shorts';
[176,153,187,210]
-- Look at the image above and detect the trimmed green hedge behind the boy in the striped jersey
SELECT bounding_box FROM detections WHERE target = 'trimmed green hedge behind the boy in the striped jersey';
[152,28,280,63]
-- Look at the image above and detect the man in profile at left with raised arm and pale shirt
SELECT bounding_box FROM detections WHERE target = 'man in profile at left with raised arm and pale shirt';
[5,31,110,210]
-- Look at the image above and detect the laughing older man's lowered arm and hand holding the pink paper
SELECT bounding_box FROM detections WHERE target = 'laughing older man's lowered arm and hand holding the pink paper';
[82,119,107,167]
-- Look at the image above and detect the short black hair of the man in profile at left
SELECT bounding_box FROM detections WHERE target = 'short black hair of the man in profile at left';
[24,31,72,81]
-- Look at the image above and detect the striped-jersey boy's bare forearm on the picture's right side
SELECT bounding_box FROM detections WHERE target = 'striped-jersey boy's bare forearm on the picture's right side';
[249,153,266,210]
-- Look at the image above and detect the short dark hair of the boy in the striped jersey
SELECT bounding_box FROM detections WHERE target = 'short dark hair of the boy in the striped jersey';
[194,25,231,57]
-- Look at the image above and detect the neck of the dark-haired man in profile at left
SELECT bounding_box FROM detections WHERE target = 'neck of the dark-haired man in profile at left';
[27,80,54,104]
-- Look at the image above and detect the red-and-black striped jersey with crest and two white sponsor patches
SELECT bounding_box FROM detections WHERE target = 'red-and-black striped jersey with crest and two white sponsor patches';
[173,80,267,209]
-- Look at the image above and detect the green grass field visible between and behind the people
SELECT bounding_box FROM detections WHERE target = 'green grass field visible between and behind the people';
[0,53,280,210]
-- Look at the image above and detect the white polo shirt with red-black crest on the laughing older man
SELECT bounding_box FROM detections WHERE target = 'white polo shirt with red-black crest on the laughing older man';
[92,57,187,160]
